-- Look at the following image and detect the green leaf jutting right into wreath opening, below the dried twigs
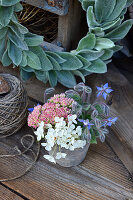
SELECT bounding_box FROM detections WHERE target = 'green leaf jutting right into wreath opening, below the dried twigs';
[25,33,43,46]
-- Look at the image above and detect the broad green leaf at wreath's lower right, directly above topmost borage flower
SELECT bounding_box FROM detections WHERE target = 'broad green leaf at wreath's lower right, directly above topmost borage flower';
[86,59,107,74]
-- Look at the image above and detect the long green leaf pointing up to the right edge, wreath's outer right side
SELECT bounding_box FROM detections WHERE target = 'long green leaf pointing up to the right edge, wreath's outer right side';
[105,19,133,42]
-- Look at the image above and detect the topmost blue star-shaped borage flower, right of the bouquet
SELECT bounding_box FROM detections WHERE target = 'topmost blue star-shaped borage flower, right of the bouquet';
[96,83,113,100]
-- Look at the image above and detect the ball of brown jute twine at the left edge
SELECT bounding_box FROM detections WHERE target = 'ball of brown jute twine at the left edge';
[0,74,28,138]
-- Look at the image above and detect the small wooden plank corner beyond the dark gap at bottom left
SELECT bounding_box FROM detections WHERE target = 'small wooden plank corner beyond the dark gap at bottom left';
[0,185,23,200]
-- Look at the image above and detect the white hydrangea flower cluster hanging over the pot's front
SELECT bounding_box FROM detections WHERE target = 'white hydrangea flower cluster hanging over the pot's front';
[42,115,86,162]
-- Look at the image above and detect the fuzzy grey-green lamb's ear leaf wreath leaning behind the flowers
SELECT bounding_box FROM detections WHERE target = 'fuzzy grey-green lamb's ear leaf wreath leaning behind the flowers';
[0,0,133,87]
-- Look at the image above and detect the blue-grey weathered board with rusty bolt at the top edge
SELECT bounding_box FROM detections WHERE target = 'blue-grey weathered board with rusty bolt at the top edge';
[22,0,69,16]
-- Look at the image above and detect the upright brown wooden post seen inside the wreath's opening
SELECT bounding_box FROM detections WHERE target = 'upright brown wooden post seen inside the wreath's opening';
[57,0,81,50]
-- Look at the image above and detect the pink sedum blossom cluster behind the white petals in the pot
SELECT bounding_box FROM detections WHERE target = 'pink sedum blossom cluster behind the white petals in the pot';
[28,94,74,128]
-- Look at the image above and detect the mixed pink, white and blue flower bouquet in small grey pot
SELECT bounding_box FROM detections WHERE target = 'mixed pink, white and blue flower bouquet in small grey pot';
[28,83,117,167]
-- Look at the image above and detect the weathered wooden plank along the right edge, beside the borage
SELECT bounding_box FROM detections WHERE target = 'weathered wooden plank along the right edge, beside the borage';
[85,65,133,176]
